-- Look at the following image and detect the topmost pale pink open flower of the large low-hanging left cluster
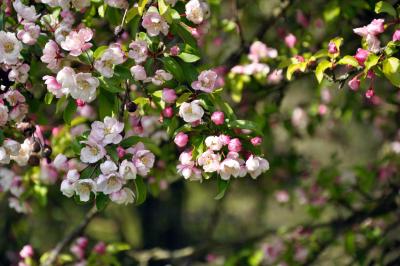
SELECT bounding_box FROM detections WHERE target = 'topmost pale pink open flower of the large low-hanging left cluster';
[90,116,124,145]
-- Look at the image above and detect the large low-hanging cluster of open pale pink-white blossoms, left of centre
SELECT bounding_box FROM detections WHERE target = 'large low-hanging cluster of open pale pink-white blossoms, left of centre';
[61,117,155,204]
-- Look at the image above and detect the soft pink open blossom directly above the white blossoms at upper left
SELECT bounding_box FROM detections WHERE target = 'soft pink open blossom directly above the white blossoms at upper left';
[61,28,93,56]
